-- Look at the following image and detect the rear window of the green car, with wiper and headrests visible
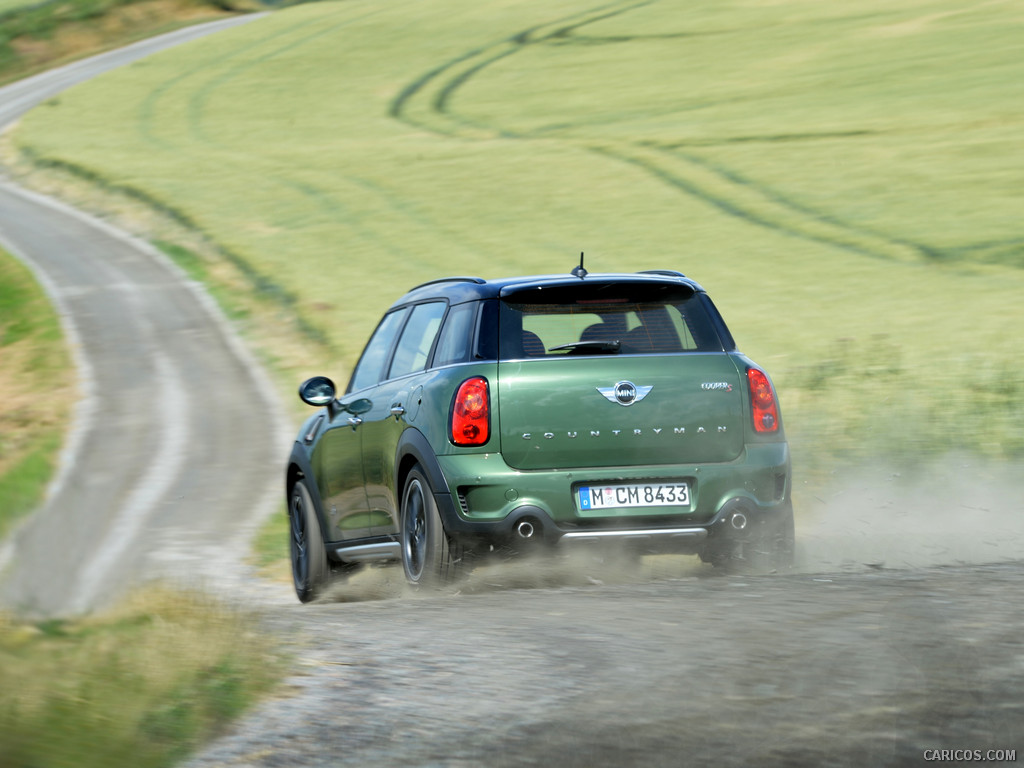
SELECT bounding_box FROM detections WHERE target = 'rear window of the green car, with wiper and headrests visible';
[500,283,722,359]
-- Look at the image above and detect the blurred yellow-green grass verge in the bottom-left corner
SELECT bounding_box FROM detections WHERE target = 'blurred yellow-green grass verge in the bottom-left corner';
[0,588,285,768]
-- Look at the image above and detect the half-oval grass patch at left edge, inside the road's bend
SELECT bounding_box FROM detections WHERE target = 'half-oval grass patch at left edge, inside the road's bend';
[0,250,76,540]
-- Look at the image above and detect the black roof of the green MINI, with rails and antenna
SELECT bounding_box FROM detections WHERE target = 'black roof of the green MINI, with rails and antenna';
[392,269,705,306]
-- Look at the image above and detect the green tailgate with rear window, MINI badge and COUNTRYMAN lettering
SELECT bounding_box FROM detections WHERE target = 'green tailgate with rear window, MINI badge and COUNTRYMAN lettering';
[496,282,744,470]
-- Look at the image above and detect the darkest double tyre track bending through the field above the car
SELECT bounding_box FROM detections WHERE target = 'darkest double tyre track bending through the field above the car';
[389,0,946,263]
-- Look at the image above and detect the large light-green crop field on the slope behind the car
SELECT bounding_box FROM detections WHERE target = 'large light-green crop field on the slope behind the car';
[14,0,1024,473]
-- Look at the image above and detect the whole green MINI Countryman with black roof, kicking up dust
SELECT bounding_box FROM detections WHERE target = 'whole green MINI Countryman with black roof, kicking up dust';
[286,266,794,601]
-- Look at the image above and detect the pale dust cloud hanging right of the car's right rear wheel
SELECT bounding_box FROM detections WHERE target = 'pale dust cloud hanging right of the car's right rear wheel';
[797,458,1024,572]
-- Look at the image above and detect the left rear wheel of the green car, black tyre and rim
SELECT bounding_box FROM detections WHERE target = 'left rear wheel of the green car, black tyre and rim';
[401,466,463,587]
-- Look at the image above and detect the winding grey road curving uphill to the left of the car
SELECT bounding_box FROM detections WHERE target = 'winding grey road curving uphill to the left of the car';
[0,16,288,614]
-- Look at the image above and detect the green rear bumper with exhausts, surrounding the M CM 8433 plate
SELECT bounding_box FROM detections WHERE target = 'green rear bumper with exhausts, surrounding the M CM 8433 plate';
[435,442,792,553]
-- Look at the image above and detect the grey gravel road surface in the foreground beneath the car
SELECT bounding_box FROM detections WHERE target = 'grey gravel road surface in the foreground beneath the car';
[189,558,1024,768]
